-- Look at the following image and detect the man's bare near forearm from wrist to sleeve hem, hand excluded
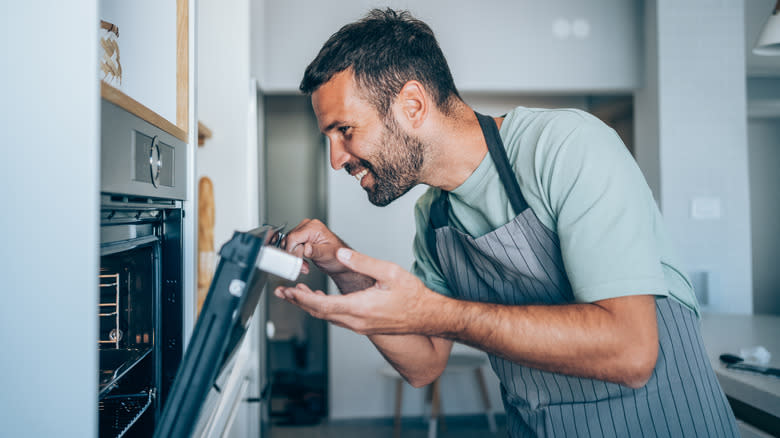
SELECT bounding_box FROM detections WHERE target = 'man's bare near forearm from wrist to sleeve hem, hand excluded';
[423,296,658,387]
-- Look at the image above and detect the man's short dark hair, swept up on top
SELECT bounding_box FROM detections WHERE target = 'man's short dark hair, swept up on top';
[300,8,460,116]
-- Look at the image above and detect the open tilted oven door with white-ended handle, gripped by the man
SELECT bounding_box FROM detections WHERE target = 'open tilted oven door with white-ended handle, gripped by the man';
[154,225,292,438]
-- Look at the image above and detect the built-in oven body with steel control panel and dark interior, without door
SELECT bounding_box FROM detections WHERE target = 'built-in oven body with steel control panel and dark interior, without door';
[95,100,187,437]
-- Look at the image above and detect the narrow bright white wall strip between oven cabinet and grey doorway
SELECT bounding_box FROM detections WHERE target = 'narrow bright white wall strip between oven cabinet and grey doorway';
[197,0,259,251]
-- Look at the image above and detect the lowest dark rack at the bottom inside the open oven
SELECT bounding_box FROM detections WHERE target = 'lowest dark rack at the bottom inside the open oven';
[98,388,156,438]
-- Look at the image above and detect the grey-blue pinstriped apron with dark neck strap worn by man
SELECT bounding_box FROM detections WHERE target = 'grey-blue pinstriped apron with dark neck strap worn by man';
[428,114,739,437]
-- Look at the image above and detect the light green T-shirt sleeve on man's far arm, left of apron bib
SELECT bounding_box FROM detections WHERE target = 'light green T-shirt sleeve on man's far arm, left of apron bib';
[411,189,452,297]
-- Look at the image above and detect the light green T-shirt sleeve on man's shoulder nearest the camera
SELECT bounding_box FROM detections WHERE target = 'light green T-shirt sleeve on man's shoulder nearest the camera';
[536,118,669,302]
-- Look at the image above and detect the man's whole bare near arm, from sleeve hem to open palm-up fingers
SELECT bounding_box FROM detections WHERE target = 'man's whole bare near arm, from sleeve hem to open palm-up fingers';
[279,250,658,388]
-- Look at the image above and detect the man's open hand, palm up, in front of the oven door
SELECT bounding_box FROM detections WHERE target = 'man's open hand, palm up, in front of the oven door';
[275,248,438,335]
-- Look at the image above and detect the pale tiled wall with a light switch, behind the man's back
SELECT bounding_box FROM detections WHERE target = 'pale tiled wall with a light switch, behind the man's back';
[635,0,753,313]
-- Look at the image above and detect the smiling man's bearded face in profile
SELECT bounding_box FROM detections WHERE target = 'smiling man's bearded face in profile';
[312,71,425,207]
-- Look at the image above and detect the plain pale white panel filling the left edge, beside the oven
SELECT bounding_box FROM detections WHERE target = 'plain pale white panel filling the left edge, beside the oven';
[0,0,100,437]
